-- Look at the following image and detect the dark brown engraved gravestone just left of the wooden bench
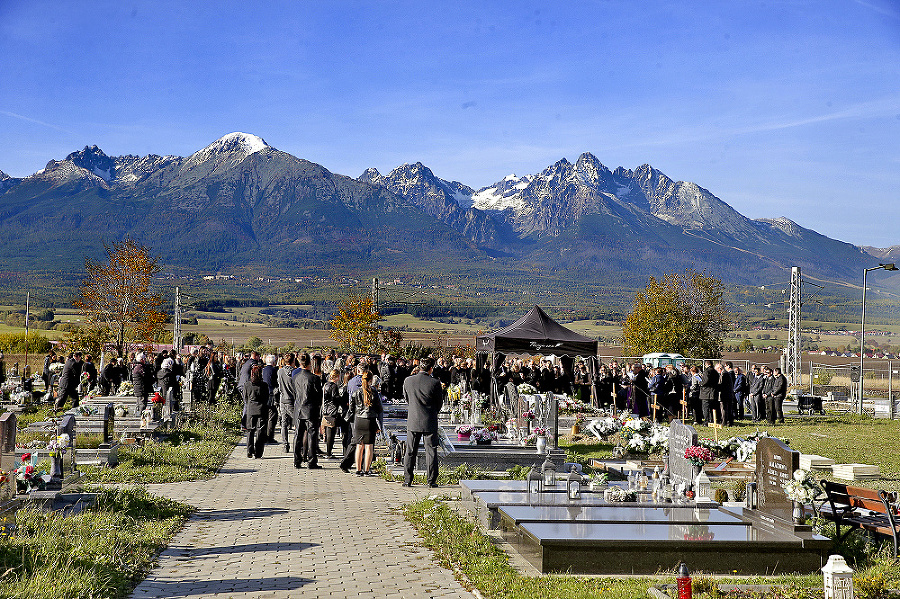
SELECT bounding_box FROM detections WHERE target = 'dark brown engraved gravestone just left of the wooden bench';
[756,437,800,522]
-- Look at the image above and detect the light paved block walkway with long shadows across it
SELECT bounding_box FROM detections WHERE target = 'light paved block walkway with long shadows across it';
[132,443,472,599]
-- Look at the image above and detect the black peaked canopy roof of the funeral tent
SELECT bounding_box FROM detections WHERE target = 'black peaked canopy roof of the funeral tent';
[475,306,597,356]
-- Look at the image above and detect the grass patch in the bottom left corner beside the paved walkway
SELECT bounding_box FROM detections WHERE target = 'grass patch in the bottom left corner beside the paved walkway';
[0,489,193,599]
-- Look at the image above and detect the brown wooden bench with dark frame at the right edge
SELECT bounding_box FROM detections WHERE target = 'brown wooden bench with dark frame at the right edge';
[821,480,900,558]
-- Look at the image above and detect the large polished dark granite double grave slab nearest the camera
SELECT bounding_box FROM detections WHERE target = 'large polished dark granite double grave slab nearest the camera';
[496,504,831,574]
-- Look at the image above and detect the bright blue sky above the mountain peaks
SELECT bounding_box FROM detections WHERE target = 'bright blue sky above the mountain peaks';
[0,0,900,247]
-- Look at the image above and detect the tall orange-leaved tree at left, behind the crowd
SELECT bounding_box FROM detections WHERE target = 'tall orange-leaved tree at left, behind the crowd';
[74,239,166,356]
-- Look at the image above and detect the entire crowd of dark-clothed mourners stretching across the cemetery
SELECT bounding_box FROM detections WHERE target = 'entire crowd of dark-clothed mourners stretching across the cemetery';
[43,346,788,480]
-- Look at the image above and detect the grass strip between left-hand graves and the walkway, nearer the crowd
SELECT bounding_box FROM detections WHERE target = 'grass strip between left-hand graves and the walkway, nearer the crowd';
[81,404,241,484]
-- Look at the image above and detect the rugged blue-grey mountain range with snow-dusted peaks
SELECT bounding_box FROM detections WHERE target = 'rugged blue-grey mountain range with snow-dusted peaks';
[0,133,897,298]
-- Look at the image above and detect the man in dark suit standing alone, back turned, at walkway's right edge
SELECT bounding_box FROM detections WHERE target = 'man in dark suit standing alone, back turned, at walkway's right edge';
[403,358,444,487]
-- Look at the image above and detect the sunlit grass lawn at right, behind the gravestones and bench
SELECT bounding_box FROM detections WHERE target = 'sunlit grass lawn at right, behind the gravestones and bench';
[560,414,900,491]
